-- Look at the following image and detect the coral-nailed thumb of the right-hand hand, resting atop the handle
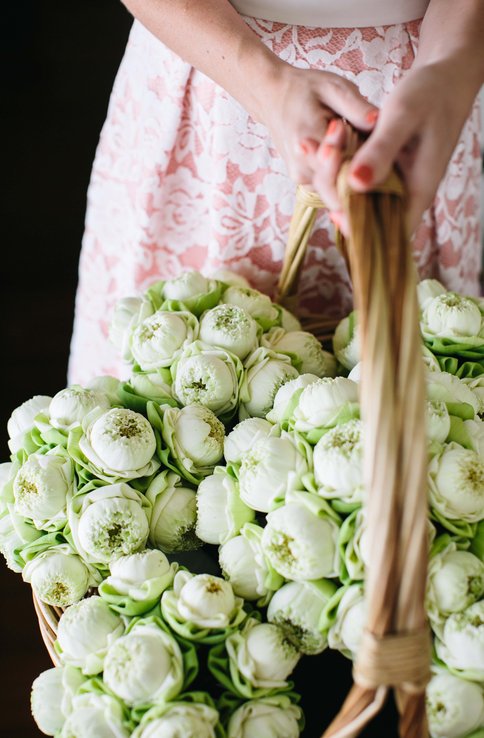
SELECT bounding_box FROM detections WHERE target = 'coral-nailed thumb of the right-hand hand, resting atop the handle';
[349,111,415,192]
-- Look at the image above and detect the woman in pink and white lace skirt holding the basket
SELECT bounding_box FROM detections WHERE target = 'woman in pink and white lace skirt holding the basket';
[70,0,484,383]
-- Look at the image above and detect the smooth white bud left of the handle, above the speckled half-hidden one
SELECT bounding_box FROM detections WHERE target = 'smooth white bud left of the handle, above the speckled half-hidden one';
[293,377,358,431]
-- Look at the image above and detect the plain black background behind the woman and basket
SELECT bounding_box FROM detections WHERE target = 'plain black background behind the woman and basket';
[0,0,396,738]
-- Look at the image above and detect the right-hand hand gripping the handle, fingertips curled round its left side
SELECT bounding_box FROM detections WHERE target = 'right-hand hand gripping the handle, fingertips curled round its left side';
[313,62,475,235]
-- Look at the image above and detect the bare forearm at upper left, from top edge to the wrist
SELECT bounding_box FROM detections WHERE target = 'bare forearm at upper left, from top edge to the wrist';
[122,0,281,120]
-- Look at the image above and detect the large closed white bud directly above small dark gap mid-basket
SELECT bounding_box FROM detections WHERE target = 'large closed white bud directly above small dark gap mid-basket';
[239,432,311,512]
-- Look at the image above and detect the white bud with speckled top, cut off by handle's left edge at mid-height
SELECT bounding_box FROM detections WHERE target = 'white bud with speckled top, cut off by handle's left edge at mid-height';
[313,420,363,503]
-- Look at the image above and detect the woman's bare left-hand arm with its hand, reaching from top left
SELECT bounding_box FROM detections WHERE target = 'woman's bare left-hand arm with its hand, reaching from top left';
[123,0,375,182]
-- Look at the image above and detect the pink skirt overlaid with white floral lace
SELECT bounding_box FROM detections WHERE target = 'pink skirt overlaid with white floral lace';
[69,18,481,383]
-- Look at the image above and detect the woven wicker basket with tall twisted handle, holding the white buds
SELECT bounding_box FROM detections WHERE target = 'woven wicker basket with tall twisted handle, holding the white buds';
[34,131,430,738]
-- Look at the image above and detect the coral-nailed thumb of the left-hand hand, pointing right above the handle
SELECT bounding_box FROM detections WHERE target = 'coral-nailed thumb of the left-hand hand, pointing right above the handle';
[321,72,379,131]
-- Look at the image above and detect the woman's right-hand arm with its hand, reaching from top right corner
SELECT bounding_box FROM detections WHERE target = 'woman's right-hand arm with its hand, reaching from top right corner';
[344,0,484,231]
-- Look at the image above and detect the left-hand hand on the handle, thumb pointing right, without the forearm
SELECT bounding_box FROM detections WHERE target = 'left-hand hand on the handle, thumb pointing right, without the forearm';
[256,62,378,196]
